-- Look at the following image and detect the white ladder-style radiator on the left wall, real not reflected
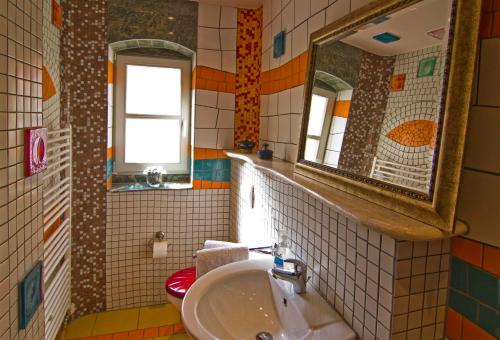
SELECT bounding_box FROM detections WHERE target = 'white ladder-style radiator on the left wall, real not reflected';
[43,128,71,340]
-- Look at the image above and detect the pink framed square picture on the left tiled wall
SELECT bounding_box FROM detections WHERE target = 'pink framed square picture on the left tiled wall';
[25,128,47,177]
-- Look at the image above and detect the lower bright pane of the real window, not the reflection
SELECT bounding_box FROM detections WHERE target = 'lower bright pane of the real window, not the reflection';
[125,118,181,164]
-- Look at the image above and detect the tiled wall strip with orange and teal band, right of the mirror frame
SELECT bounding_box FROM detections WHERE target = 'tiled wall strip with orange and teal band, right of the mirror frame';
[447,0,500,340]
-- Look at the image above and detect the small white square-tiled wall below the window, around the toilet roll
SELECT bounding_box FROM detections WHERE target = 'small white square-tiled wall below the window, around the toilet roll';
[106,189,230,309]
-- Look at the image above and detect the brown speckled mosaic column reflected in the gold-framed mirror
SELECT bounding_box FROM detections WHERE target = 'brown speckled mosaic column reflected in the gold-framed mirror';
[339,52,394,176]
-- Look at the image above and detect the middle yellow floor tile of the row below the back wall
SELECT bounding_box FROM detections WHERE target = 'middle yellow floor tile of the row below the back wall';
[92,308,139,335]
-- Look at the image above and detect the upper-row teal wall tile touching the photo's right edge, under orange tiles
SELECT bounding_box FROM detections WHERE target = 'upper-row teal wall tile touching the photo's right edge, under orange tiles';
[469,266,500,308]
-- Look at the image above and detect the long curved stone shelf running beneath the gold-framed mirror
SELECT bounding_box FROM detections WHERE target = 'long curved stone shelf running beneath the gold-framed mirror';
[225,150,467,241]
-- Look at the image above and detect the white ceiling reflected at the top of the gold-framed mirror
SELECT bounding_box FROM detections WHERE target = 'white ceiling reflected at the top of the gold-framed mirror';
[342,0,451,56]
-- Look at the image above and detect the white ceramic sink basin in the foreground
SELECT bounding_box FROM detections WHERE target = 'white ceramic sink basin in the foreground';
[182,256,356,340]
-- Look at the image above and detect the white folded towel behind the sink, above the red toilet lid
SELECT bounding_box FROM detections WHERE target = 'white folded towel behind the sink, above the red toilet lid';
[196,246,248,278]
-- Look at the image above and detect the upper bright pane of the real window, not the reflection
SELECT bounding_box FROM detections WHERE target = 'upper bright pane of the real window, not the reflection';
[125,65,181,116]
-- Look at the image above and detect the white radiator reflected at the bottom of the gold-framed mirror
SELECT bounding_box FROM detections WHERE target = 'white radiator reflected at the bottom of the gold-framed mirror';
[370,157,432,191]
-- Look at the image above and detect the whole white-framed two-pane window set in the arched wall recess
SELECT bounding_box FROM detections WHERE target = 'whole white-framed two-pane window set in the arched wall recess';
[115,55,191,174]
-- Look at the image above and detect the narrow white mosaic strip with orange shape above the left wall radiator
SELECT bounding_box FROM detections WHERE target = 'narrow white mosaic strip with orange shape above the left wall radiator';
[42,1,61,129]
